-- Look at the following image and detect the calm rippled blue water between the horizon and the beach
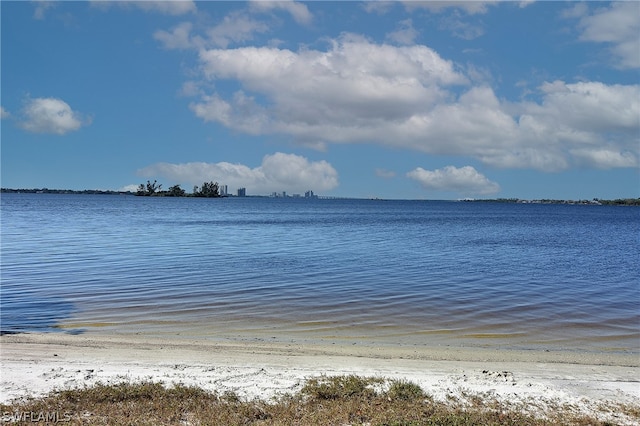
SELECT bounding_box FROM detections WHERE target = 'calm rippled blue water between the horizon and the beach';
[1,194,640,353]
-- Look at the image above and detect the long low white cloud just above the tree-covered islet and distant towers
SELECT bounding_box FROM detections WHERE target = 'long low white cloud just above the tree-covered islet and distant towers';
[138,152,338,194]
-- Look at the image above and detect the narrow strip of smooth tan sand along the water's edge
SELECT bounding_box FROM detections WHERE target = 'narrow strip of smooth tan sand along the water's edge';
[0,332,640,366]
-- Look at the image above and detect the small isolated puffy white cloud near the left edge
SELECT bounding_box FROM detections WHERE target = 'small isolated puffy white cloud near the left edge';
[19,98,90,135]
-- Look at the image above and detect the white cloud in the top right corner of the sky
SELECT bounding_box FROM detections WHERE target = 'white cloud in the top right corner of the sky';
[563,1,640,69]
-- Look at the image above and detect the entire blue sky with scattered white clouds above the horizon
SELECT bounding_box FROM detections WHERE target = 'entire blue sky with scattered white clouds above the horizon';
[0,1,640,199]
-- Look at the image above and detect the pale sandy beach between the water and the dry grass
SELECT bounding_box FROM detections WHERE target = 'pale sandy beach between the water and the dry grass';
[0,333,640,424]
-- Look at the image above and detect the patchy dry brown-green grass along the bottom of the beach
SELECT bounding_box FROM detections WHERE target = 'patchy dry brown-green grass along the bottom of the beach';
[0,375,640,426]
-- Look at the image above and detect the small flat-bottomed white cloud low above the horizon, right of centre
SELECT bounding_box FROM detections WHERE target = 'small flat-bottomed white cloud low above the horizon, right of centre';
[407,166,500,195]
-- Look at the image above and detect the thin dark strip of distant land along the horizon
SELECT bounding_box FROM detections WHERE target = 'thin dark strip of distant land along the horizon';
[0,188,640,206]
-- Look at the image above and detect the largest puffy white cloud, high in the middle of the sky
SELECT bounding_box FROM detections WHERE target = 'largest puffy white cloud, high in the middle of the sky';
[191,35,467,141]
